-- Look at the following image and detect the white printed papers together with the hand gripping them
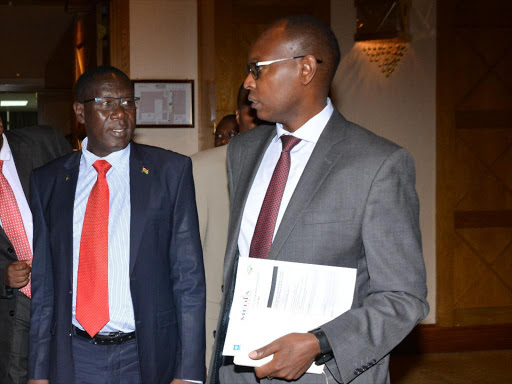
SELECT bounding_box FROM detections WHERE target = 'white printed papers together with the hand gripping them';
[223,258,356,380]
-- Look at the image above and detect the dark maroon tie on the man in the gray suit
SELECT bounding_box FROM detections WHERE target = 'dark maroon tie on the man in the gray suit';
[249,135,300,259]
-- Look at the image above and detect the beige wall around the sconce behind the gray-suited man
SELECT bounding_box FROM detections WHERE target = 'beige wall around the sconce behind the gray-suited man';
[331,0,436,323]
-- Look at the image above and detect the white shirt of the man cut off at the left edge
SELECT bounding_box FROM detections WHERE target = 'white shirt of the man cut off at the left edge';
[0,134,34,253]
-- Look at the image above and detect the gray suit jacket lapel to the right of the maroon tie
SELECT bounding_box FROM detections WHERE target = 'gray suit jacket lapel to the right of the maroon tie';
[268,110,346,259]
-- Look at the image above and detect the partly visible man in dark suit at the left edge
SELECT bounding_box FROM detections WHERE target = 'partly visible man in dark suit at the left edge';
[0,118,71,384]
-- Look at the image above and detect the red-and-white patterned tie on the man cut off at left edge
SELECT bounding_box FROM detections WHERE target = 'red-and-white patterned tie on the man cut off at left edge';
[0,160,32,299]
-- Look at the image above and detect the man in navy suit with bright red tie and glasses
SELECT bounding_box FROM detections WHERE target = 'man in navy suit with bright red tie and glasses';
[29,67,205,384]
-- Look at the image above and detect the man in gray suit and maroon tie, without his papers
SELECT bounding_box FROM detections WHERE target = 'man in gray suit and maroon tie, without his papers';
[209,16,428,384]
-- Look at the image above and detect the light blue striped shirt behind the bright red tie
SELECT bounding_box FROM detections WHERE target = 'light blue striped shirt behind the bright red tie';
[73,138,135,334]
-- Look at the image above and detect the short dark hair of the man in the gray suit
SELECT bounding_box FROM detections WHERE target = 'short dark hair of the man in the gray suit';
[269,15,341,84]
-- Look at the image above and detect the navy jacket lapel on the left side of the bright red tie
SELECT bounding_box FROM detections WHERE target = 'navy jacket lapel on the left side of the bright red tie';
[62,151,82,284]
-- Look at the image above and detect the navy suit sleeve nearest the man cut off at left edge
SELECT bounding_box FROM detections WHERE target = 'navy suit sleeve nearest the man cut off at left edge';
[29,173,54,379]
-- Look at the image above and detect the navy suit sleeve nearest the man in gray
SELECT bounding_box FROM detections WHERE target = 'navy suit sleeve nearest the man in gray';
[169,159,206,381]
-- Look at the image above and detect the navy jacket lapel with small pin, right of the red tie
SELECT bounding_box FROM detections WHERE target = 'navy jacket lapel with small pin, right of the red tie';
[130,142,154,275]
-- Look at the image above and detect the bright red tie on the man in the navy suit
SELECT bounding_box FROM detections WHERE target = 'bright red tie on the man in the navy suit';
[76,160,111,337]
